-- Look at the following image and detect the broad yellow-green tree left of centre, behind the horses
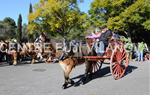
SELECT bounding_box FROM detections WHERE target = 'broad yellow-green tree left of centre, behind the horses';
[28,0,87,38]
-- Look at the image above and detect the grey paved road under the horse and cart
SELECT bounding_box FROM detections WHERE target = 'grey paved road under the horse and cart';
[0,61,150,95]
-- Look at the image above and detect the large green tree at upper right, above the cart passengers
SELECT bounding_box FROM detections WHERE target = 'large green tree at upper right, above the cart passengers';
[89,0,150,40]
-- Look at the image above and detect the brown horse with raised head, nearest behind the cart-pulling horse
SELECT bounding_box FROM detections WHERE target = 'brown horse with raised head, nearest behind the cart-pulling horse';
[35,33,56,63]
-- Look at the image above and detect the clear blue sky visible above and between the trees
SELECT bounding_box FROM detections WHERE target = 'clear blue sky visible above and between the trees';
[0,0,93,23]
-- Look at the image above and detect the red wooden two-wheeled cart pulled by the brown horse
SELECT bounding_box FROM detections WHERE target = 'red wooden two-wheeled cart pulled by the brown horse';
[83,39,129,80]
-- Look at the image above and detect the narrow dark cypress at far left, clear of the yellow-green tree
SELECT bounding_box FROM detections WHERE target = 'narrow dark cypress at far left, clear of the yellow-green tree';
[17,14,22,42]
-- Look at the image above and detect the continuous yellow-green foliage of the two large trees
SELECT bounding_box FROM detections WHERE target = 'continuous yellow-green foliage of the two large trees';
[28,0,150,40]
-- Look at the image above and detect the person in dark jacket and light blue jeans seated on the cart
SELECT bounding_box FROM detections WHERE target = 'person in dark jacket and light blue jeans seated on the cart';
[94,26,113,56]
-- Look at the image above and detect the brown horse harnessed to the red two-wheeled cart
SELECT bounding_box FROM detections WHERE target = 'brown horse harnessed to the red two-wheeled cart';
[59,39,99,89]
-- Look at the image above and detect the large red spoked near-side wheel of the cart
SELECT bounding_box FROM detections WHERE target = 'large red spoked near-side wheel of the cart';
[110,47,129,80]
